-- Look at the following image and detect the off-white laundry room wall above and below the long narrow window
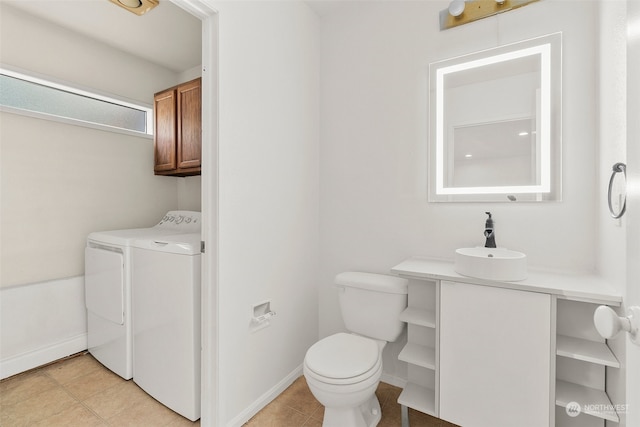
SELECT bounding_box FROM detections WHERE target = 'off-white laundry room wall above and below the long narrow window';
[0,4,185,286]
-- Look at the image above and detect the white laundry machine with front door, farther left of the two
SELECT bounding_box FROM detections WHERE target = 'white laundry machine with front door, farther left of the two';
[85,211,201,380]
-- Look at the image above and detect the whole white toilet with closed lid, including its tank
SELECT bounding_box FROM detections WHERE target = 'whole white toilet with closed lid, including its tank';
[304,272,407,427]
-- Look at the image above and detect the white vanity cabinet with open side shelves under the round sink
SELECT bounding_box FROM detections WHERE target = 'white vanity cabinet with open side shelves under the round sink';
[392,258,622,427]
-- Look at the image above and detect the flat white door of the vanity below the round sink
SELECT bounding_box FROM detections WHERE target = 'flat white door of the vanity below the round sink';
[439,281,552,427]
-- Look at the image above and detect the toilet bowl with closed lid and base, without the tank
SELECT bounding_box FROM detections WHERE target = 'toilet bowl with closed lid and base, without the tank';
[303,333,386,427]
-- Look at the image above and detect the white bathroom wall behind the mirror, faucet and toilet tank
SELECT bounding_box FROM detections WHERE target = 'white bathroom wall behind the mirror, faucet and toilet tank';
[319,0,600,377]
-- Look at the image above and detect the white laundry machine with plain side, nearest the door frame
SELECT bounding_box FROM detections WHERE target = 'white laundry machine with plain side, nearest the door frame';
[131,234,200,421]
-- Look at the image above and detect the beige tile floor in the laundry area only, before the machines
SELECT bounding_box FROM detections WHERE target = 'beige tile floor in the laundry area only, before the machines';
[0,354,200,427]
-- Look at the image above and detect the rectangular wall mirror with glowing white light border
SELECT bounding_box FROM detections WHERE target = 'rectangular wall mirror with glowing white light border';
[429,33,562,202]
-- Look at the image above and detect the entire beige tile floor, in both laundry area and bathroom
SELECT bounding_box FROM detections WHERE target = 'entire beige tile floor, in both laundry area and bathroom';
[0,354,455,427]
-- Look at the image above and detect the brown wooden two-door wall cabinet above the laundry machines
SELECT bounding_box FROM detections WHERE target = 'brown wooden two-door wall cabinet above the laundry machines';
[153,78,202,176]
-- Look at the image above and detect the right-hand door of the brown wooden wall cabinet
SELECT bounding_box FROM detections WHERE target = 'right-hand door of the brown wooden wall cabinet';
[178,79,202,169]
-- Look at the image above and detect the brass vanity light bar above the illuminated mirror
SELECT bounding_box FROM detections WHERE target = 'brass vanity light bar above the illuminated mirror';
[440,0,538,31]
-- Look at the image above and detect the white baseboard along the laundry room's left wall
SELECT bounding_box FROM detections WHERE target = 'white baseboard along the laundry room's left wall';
[0,334,87,379]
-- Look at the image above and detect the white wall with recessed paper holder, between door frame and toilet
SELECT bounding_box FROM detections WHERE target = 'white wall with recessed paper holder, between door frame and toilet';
[213,1,320,426]
